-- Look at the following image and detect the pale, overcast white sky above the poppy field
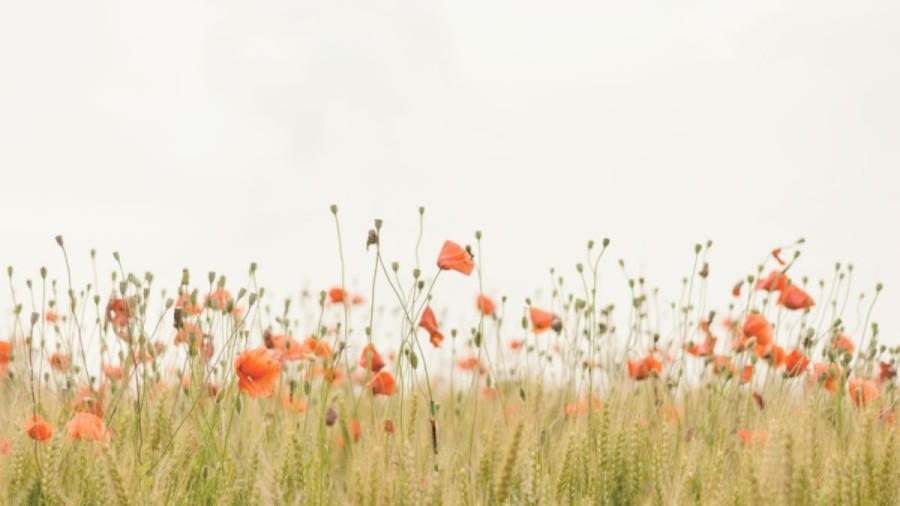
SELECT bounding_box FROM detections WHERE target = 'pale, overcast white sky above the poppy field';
[0,0,900,342]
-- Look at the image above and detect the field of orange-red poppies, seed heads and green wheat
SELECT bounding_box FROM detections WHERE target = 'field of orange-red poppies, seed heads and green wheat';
[0,207,900,505]
